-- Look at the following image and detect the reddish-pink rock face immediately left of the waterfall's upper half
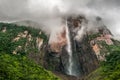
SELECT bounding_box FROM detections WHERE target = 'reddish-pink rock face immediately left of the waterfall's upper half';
[50,28,67,53]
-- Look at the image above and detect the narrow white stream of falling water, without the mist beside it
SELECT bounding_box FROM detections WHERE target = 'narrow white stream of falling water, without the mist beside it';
[66,21,73,75]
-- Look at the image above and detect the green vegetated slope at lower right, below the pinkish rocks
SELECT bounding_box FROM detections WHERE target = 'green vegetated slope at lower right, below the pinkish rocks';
[86,42,120,80]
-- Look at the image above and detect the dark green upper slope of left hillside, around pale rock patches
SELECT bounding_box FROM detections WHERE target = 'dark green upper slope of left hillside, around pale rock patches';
[0,23,47,54]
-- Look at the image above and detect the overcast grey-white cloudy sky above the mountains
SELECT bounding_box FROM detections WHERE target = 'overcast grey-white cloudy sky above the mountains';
[0,0,120,39]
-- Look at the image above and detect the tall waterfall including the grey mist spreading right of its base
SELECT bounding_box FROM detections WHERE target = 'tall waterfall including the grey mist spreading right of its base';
[66,20,80,76]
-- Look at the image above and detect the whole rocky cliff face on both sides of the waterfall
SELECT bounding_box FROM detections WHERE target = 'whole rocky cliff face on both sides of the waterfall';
[45,16,114,77]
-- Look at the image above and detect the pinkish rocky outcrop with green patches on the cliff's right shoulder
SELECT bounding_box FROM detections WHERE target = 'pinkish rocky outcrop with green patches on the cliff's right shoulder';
[90,27,114,61]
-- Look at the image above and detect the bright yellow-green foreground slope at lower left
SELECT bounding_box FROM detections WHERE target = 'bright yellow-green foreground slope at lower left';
[0,53,59,80]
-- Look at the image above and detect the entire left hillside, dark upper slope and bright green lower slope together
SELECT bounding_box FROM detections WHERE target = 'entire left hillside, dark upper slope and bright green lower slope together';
[0,23,59,80]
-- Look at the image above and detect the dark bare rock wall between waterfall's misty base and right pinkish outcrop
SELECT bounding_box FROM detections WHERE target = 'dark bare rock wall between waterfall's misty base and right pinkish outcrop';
[76,36,99,76]
